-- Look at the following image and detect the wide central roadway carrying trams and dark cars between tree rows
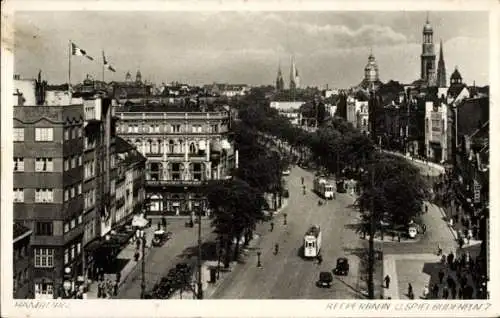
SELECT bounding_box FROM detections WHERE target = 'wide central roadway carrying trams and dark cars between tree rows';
[212,167,364,299]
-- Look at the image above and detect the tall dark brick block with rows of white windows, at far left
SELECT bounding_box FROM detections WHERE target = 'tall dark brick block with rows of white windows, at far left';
[13,75,145,298]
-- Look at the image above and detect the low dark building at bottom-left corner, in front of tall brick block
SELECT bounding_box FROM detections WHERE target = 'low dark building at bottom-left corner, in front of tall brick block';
[12,223,33,299]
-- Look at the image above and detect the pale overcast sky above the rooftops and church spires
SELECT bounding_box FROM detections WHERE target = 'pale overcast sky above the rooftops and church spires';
[15,11,489,88]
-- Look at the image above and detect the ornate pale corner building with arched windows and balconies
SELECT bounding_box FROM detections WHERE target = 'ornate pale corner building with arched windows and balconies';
[115,105,237,216]
